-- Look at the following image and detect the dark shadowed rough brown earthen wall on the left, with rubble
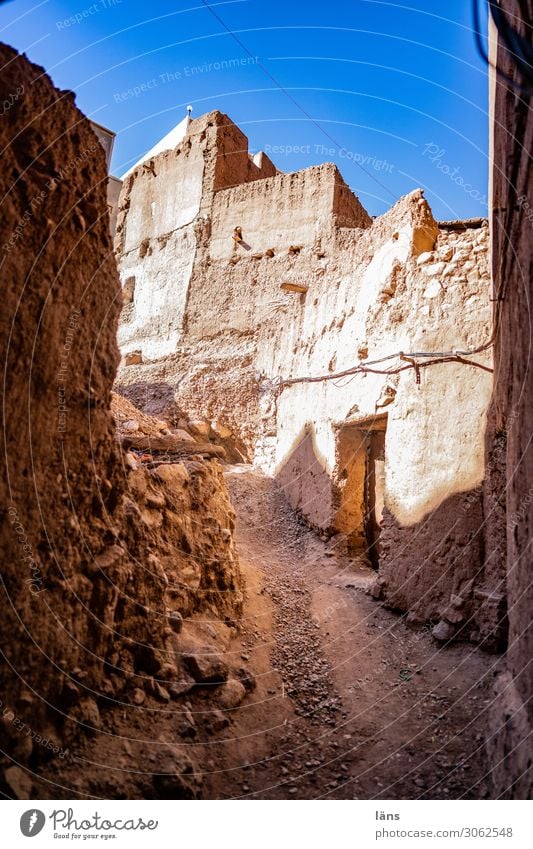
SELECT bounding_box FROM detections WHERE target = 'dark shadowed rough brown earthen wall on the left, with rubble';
[0,45,242,798]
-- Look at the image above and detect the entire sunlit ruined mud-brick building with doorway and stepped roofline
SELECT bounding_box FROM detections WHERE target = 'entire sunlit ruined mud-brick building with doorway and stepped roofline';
[115,112,496,647]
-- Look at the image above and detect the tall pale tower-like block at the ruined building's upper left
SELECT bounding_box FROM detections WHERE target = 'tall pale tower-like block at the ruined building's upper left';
[116,112,275,360]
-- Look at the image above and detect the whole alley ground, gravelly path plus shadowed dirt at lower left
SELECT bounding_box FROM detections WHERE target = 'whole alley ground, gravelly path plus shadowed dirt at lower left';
[34,466,496,799]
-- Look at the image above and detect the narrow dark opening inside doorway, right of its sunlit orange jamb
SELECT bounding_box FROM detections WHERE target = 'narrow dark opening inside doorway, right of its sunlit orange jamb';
[365,430,385,569]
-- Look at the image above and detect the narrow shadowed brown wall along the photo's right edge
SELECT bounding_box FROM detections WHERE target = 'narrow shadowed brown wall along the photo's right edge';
[484,0,533,799]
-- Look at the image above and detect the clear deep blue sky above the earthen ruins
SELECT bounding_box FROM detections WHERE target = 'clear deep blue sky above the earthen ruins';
[0,0,488,220]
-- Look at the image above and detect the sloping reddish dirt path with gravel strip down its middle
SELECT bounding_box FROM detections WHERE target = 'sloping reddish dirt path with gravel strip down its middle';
[203,467,495,799]
